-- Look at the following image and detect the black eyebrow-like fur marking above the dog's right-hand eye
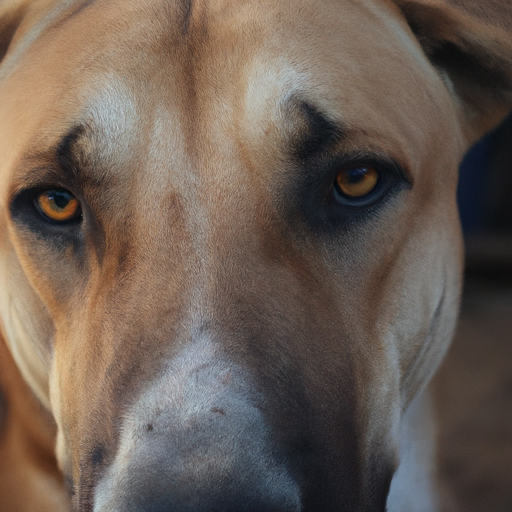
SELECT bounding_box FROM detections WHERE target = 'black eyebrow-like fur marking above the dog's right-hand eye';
[287,99,347,160]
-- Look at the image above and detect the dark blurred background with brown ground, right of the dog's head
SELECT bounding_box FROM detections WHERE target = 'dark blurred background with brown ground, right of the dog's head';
[434,116,512,512]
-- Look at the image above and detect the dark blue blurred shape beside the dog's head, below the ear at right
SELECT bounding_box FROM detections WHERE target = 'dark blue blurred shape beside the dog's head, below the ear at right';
[457,134,492,236]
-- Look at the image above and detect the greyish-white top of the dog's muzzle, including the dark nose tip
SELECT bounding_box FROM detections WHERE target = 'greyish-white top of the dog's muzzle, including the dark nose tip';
[94,340,301,512]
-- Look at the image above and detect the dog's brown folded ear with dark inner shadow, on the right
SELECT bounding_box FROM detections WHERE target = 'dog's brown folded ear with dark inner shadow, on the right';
[394,0,512,143]
